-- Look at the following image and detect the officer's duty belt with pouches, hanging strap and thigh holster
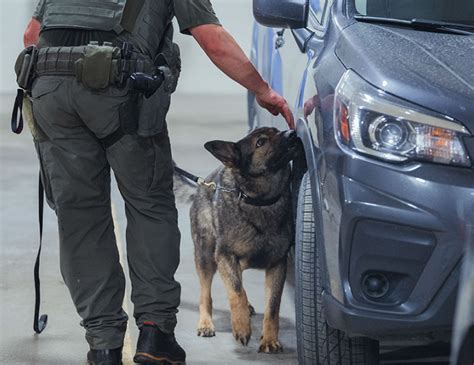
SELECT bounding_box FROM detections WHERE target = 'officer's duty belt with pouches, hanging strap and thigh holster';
[11,43,179,140]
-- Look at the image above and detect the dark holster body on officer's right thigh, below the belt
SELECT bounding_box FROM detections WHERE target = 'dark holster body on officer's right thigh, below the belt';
[137,85,171,137]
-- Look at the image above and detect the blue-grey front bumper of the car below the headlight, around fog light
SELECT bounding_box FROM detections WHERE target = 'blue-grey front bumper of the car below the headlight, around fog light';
[322,150,474,339]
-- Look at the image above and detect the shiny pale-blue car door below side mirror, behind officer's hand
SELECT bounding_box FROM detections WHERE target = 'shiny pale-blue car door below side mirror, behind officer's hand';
[249,0,333,129]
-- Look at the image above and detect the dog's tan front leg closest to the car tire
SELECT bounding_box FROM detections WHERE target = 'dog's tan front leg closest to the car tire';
[258,258,286,353]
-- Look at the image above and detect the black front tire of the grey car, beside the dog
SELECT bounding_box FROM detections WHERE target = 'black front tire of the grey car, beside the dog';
[295,172,379,365]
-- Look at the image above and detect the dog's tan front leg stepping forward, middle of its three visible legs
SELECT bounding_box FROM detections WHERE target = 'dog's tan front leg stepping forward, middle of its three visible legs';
[217,255,252,346]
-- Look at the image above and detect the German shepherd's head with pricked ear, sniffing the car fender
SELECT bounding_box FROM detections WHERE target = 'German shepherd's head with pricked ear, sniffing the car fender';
[204,127,299,177]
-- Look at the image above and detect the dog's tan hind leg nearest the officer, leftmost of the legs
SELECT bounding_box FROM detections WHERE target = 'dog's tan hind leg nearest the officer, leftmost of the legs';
[195,240,217,337]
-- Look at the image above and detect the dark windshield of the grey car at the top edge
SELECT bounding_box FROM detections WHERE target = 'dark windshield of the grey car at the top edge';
[354,0,474,25]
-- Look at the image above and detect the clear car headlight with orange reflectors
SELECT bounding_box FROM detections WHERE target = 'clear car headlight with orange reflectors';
[334,70,471,166]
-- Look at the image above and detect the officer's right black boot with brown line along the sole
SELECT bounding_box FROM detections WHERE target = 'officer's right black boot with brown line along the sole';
[133,322,186,365]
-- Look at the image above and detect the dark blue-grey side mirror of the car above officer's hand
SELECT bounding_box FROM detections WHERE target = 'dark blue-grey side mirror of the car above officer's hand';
[253,0,309,29]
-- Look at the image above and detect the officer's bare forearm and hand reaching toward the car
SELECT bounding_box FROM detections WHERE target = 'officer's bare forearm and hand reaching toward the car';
[189,24,294,128]
